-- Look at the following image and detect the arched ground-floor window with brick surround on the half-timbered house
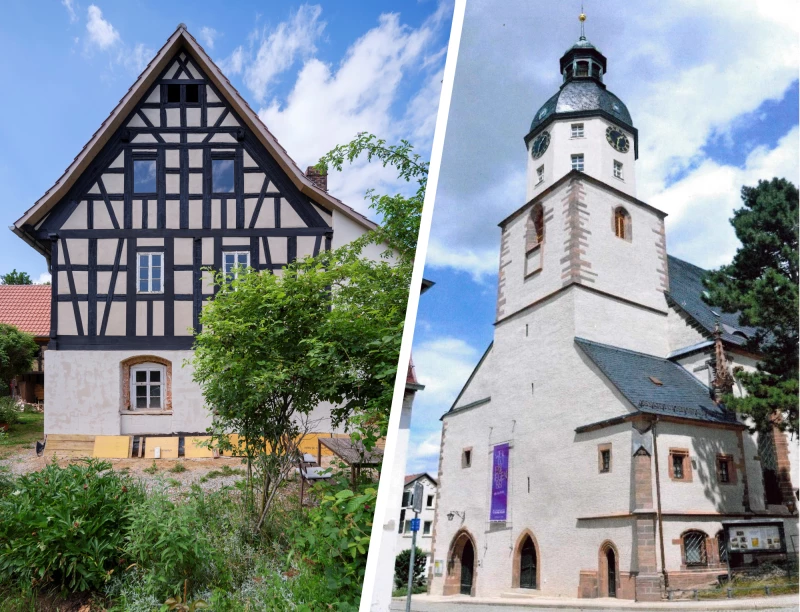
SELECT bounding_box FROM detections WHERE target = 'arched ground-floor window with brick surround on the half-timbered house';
[120,355,172,411]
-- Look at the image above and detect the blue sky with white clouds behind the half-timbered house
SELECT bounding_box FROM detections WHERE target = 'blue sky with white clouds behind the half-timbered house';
[0,0,452,280]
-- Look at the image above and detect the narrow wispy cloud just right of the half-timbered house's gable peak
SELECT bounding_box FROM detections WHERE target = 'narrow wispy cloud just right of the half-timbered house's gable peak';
[244,4,325,102]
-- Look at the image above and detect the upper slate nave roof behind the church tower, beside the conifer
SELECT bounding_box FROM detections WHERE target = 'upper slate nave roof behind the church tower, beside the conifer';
[667,255,756,345]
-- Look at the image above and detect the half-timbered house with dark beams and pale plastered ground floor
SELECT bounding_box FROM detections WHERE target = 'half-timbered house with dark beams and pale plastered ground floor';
[12,24,380,444]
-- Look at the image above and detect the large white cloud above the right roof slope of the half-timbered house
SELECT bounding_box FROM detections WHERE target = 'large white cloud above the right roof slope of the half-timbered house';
[259,9,443,212]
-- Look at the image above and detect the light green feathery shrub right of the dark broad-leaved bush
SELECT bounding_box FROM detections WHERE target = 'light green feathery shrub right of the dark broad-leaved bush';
[125,491,215,601]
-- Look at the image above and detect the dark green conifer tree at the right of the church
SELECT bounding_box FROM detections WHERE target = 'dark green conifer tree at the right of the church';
[704,178,800,432]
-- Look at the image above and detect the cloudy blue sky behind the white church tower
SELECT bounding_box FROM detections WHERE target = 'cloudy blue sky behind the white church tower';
[407,0,800,474]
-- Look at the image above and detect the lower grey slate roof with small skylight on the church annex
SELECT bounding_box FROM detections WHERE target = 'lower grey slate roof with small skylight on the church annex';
[575,338,738,423]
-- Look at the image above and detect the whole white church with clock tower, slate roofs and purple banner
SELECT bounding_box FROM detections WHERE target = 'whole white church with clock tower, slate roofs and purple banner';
[429,22,798,600]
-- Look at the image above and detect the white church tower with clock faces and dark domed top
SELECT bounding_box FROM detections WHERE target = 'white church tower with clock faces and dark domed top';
[497,15,669,354]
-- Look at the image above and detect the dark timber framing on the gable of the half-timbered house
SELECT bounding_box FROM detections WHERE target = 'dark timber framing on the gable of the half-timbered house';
[32,48,333,350]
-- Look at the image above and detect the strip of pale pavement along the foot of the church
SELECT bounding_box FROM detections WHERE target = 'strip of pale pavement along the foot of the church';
[391,591,798,612]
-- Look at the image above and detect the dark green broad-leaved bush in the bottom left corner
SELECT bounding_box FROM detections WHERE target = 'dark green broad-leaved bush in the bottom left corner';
[0,459,144,592]
